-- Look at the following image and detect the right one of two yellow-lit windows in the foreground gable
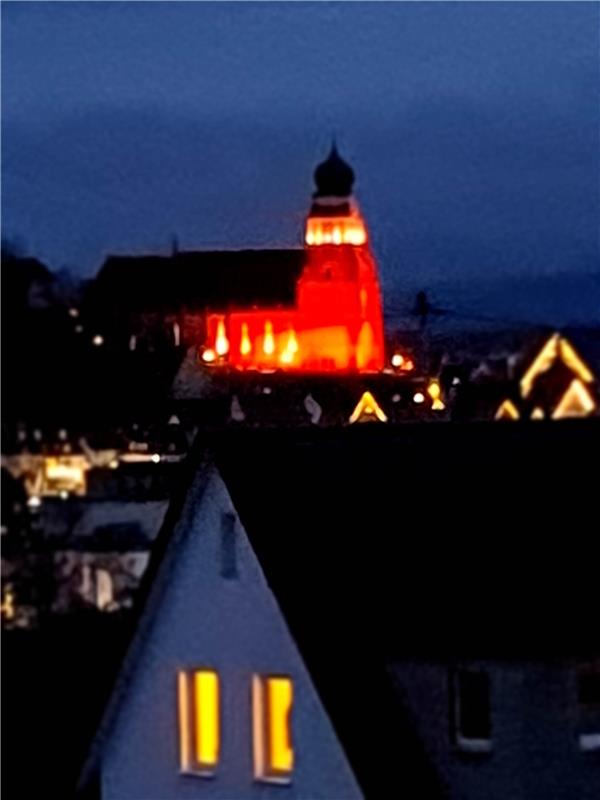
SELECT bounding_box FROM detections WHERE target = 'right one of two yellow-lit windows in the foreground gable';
[252,675,294,783]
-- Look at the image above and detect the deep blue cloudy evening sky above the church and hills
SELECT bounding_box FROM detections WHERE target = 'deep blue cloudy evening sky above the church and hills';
[2,2,600,318]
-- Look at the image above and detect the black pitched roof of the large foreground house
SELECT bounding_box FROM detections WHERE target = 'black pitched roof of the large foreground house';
[78,420,600,797]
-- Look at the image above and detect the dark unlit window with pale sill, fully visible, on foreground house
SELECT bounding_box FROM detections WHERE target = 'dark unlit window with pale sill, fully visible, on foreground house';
[450,669,492,753]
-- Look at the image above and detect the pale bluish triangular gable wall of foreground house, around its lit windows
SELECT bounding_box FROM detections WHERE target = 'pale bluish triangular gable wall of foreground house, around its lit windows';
[100,472,361,800]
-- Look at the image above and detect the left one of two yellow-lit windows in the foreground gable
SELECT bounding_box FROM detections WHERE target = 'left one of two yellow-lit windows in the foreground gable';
[177,669,221,775]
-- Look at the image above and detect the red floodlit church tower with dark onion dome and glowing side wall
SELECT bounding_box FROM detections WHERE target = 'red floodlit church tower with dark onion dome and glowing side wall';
[202,146,385,373]
